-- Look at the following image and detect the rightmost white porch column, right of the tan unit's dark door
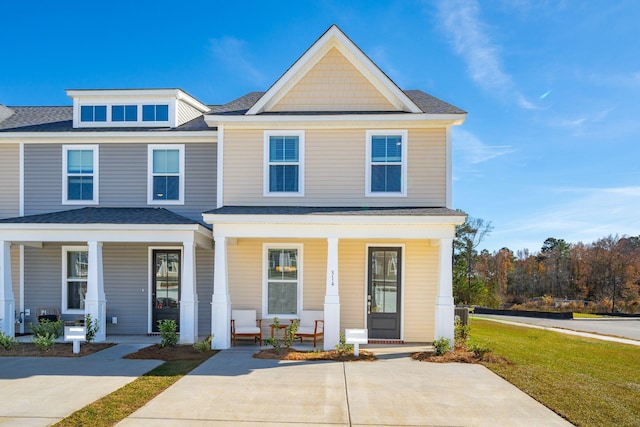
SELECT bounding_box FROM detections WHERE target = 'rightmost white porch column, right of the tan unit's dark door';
[435,239,454,346]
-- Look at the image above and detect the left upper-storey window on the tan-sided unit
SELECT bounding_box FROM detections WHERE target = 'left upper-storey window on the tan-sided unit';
[264,131,304,196]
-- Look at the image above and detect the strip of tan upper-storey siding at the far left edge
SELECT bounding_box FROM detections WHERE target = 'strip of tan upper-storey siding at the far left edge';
[0,144,20,218]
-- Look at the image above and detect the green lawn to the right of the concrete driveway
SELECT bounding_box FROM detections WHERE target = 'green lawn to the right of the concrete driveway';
[470,319,640,426]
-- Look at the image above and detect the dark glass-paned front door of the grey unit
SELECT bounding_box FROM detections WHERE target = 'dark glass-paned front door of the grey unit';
[151,249,180,332]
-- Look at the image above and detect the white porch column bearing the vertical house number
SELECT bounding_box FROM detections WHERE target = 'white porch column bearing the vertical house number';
[324,237,340,350]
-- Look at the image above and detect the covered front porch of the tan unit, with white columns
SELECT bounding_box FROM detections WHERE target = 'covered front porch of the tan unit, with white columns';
[203,207,464,350]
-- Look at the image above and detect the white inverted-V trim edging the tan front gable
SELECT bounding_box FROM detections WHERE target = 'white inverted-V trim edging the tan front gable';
[246,25,422,115]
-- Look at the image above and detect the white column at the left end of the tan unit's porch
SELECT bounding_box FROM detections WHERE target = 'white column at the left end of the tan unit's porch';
[211,236,231,350]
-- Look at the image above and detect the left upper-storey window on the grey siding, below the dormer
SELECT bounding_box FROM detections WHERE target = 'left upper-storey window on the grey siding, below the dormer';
[62,145,99,205]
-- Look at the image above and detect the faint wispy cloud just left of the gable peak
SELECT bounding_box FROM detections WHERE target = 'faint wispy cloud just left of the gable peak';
[210,36,267,86]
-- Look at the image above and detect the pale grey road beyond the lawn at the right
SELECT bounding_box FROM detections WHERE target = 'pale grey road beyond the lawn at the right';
[471,314,640,341]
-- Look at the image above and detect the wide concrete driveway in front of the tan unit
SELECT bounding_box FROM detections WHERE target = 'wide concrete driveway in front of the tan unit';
[119,346,571,427]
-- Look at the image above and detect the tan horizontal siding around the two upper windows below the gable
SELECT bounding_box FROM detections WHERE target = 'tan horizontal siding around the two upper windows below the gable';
[224,129,446,207]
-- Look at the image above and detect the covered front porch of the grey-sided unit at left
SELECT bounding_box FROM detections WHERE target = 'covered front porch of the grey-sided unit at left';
[0,208,213,343]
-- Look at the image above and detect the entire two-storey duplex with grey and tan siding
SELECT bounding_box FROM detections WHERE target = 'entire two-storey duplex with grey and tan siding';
[0,26,466,349]
